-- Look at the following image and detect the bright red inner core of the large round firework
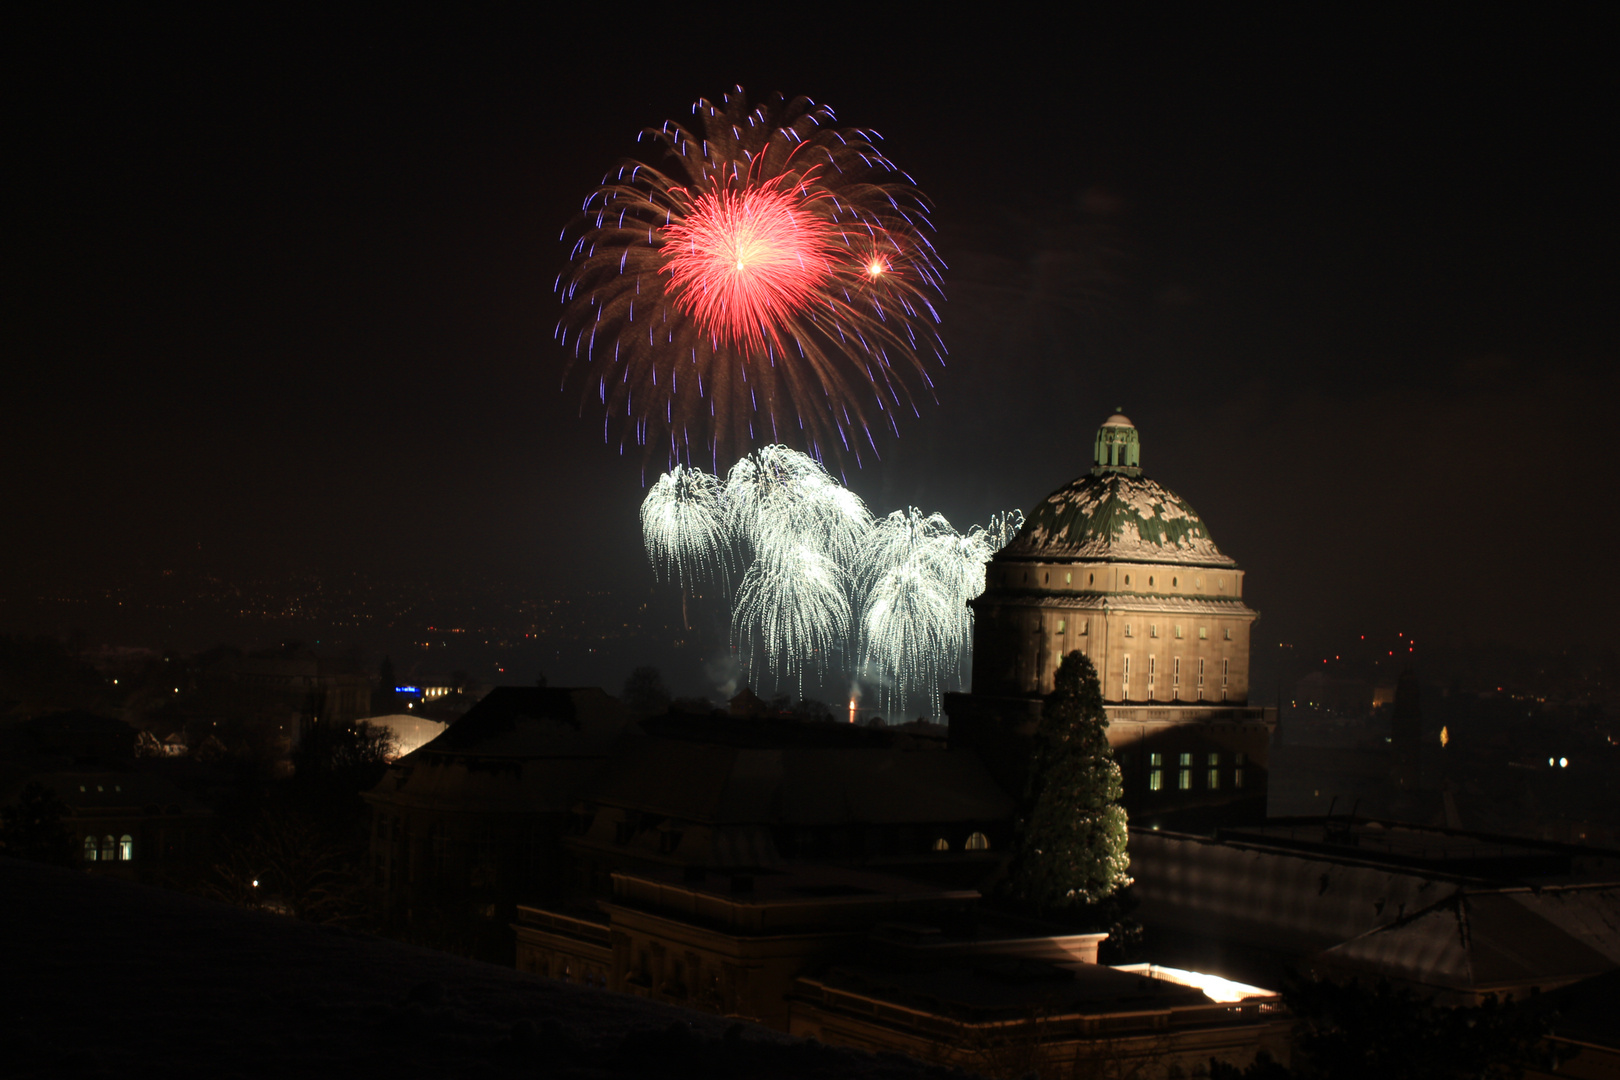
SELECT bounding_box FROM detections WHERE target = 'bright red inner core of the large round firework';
[663,186,839,355]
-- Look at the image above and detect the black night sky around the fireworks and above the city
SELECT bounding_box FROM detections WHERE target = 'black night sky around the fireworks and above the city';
[0,5,1620,693]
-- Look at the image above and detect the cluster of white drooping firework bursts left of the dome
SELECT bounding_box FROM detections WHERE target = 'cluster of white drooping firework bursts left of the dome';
[642,445,1022,716]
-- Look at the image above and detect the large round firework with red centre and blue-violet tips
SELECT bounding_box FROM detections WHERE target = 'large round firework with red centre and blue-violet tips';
[557,87,944,471]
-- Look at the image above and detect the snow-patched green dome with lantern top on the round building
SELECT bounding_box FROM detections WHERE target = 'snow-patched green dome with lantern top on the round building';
[1000,413,1234,567]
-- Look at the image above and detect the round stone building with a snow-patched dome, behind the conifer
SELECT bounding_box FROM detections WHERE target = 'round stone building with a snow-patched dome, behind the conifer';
[946,413,1275,811]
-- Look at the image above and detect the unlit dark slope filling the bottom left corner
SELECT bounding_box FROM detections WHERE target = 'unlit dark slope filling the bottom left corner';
[0,858,964,1080]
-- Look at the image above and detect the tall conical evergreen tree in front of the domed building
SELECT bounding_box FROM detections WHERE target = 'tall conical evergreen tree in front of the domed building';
[1009,651,1131,910]
